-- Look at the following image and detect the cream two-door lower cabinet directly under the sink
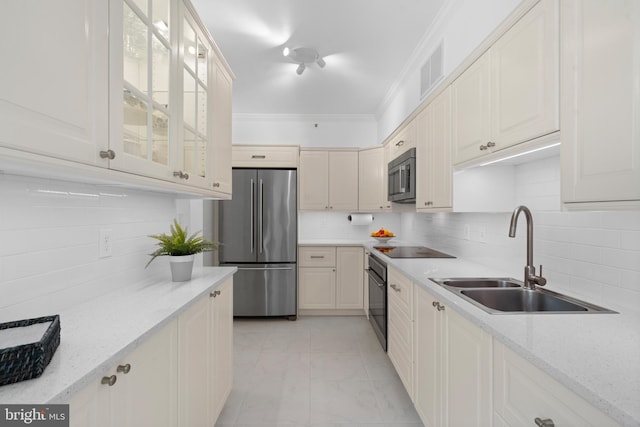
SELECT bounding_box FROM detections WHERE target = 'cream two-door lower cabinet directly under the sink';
[414,285,492,427]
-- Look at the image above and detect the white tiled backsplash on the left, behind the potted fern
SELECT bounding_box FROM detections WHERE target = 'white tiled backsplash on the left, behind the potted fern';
[0,174,192,322]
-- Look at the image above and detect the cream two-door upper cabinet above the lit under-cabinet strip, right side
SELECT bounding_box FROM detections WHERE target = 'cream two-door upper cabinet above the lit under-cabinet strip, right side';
[452,0,559,164]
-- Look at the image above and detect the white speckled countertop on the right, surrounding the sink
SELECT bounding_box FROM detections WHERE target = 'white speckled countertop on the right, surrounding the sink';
[364,242,640,426]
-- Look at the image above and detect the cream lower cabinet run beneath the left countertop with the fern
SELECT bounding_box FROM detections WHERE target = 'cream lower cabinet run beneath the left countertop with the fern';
[69,278,233,427]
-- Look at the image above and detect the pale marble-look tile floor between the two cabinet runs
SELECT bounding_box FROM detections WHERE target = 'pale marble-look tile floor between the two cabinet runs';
[216,316,422,427]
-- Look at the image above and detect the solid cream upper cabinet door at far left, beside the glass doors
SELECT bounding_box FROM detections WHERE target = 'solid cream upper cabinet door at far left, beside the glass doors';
[0,0,109,166]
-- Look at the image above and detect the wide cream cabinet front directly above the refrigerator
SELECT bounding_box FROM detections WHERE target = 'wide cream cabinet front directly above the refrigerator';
[231,145,299,168]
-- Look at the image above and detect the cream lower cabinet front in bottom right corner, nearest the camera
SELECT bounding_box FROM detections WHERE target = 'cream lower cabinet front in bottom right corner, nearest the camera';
[493,341,618,427]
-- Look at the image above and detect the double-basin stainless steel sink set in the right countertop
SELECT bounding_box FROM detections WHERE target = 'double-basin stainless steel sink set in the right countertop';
[430,278,615,314]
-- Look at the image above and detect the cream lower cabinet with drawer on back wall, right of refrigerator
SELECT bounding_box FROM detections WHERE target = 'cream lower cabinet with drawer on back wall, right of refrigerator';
[298,246,364,310]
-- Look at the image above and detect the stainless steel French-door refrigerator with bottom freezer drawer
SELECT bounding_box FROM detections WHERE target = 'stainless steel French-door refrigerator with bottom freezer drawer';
[218,168,298,320]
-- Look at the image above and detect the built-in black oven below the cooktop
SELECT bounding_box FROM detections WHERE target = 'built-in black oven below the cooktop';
[368,254,387,351]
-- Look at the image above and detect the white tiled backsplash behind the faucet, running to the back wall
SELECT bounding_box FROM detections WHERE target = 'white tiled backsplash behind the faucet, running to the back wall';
[300,157,640,311]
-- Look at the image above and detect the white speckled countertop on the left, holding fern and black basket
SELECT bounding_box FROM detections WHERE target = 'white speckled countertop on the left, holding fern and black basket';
[0,267,236,404]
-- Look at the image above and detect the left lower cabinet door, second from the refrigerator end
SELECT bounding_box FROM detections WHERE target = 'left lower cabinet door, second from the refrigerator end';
[178,298,213,427]
